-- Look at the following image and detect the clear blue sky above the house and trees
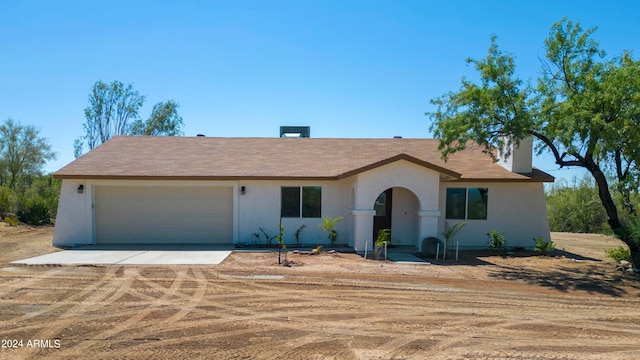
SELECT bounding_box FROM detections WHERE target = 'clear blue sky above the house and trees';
[0,0,640,178]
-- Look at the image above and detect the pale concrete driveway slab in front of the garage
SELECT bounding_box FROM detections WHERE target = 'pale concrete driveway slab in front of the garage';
[12,245,232,265]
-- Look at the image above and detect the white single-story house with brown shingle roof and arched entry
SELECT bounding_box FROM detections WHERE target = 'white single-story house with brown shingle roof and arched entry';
[53,136,553,252]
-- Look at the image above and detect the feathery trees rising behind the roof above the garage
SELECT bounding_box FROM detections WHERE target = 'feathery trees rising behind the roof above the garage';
[74,81,184,158]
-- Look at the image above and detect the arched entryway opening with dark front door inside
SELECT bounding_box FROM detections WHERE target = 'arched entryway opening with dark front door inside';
[372,187,420,246]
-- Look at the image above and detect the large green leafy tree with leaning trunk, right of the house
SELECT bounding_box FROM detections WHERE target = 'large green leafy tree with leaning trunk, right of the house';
[427,19,640,268]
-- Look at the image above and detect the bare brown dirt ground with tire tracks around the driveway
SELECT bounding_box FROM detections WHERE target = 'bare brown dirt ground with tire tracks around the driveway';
[0,227,640,359]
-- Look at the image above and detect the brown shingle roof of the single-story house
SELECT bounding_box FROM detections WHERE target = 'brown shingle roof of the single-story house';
[54,136,553,181]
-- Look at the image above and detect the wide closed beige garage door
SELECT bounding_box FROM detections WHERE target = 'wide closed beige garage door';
[95,186,233,244]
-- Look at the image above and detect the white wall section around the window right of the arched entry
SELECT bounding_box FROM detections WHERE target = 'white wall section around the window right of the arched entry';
[437,182,550,249]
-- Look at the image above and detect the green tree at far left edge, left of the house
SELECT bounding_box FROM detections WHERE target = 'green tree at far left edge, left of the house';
[0,119,57,189]
